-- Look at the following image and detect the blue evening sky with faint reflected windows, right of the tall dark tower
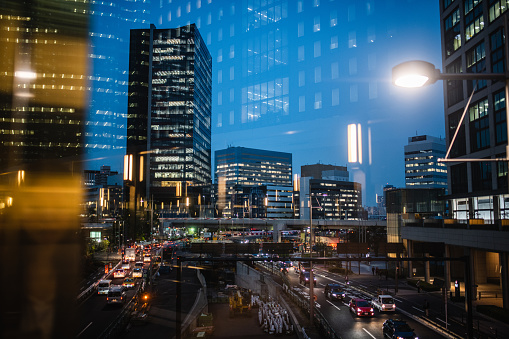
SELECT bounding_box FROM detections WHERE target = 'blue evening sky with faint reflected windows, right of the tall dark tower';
[155,0,442,205]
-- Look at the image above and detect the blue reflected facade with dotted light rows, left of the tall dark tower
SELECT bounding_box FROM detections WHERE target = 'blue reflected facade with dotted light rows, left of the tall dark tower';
[85,0,150,170]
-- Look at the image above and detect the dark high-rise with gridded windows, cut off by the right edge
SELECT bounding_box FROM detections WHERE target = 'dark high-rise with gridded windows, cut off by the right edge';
[401,0,509,309]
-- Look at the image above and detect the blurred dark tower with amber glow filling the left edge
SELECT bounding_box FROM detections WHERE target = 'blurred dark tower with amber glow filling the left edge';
[0,0,88,338]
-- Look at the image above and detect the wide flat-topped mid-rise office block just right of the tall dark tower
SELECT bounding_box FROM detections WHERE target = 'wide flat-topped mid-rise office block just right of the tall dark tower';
[214,147,293,218]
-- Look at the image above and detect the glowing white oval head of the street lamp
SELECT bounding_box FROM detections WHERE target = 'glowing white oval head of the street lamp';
[392,60,440,88]
